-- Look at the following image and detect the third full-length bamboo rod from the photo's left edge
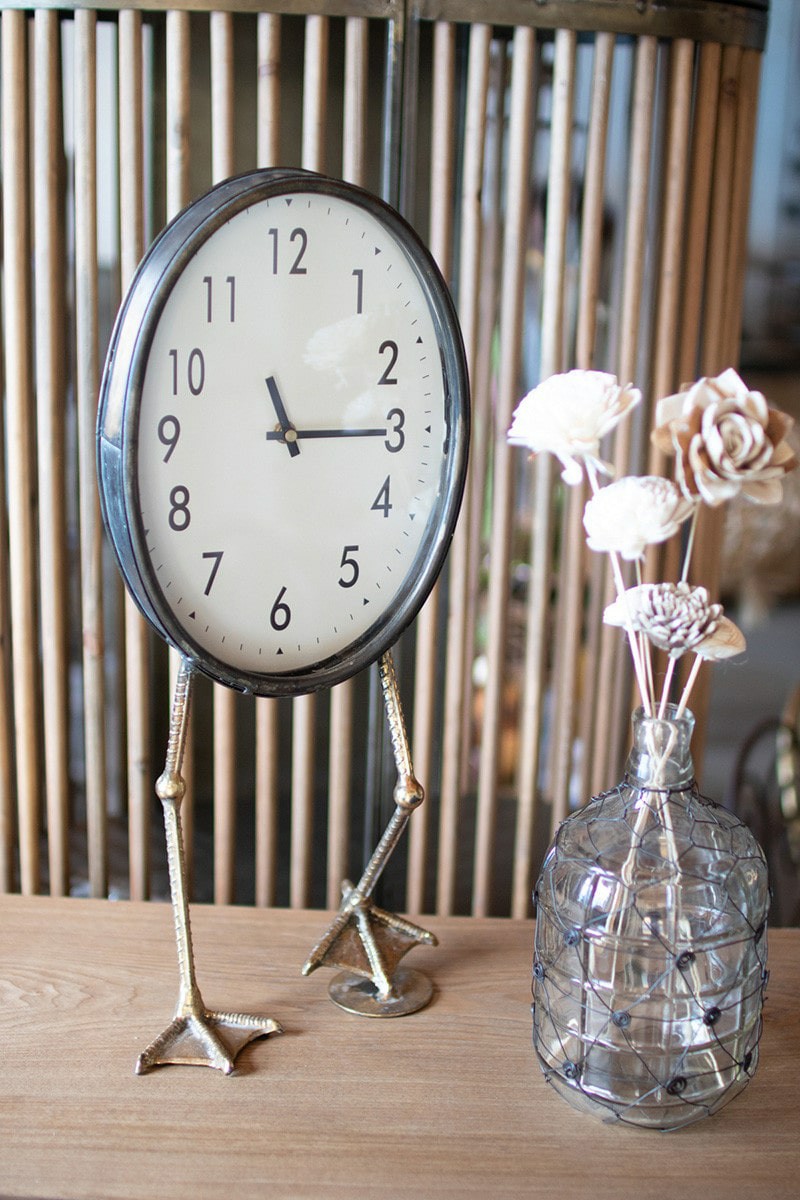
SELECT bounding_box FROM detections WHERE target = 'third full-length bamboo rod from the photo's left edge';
[74,10,108,896]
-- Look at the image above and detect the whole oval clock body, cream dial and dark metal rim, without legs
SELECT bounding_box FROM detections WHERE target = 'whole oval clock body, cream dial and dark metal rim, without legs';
[100,172,468,694]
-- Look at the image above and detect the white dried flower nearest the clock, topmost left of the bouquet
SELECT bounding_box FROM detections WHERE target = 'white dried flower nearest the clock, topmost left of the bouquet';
[509,371,642,485]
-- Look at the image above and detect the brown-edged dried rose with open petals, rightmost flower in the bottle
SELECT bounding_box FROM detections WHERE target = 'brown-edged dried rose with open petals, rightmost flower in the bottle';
[652,367,796,506]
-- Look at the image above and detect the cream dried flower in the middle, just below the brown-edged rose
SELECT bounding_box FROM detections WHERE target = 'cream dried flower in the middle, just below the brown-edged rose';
[583,475,694,559]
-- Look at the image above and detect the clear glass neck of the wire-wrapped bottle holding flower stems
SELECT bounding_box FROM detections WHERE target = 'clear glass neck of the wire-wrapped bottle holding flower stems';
[626,704,694,791]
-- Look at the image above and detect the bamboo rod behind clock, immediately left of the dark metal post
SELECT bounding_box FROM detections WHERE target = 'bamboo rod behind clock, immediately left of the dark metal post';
[326,17,368,908]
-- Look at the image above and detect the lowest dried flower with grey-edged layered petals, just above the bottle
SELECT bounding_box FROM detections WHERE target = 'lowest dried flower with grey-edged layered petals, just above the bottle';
[603,582,746,659]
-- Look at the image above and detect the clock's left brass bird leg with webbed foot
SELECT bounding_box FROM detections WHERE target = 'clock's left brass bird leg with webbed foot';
[136,662,281,1074]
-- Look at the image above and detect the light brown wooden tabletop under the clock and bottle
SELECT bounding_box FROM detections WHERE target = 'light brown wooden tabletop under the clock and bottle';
[0,895,800,1200]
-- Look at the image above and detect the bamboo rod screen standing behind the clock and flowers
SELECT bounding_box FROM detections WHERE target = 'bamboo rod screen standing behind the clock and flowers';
[0,0,764,914]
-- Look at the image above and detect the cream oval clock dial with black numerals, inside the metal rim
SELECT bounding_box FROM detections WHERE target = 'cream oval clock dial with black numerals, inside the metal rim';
[138,192,446,673]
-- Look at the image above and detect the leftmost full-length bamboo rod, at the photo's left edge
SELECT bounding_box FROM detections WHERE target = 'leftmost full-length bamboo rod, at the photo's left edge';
[1,11,40,895]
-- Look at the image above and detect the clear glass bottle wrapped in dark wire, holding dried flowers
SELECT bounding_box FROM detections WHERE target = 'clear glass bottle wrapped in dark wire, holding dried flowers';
[533,706,769,1129]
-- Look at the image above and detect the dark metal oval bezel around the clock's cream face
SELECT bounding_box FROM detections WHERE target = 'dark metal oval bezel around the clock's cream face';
[97,168,469,696]
